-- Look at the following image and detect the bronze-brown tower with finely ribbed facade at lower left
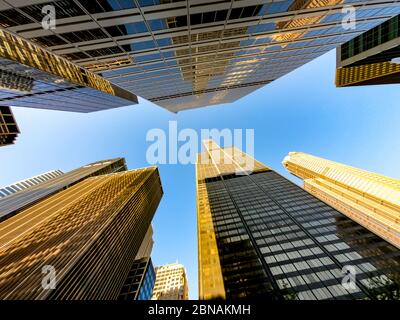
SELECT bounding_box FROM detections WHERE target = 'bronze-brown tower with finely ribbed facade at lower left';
[0,167,163,300]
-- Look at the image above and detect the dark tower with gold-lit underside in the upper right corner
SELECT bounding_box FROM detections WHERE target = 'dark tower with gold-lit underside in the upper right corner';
[336,15,400,87]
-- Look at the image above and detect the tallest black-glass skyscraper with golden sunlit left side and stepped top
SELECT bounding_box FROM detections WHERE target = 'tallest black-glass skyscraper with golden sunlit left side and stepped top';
[196,141,400,300]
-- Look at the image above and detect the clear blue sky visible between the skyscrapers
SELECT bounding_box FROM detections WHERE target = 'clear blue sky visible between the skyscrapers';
[0,51,400,299]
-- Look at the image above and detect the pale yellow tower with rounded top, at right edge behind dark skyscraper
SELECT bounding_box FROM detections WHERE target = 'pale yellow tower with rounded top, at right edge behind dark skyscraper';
[283,152,400,248]
